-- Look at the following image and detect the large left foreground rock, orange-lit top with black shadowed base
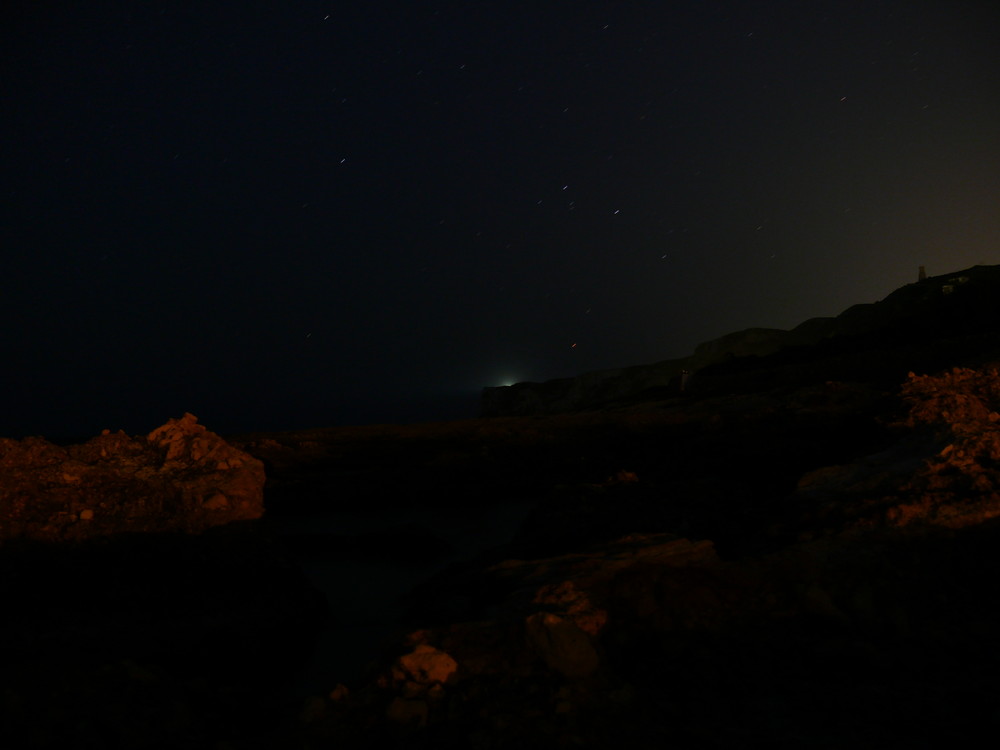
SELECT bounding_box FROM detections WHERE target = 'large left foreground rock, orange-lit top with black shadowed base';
[0,414,326,750]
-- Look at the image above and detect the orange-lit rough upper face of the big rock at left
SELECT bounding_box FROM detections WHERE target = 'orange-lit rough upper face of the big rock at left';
[0,414,264,541]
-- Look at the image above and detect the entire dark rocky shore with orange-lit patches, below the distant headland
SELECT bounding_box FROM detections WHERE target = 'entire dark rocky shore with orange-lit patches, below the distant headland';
[0,269,1000,750]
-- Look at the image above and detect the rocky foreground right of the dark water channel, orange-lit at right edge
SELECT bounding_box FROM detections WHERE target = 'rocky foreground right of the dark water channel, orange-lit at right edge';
[302,367,1000,749]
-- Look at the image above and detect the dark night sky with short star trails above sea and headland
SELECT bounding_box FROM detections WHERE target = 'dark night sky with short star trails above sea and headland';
[0,0,1000,437]
